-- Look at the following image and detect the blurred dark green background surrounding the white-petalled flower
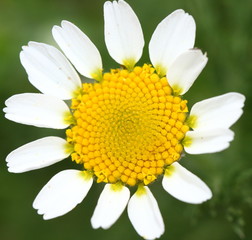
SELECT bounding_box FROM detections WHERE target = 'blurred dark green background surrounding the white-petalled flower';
[0,0,252,240]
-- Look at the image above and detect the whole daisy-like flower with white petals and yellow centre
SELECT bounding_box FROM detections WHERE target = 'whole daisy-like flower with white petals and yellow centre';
[4,0,245,239]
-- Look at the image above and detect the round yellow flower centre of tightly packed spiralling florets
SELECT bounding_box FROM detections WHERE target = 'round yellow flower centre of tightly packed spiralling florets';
[66,64,189,186]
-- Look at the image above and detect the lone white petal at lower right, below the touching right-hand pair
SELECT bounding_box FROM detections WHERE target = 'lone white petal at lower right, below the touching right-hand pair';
[162,162,212,204]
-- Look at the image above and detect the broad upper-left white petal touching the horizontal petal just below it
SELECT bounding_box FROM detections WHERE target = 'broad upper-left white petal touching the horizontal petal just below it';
[20,42,81,99]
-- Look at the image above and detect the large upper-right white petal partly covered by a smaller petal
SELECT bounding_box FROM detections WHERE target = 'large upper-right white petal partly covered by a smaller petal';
[149,9,196,75]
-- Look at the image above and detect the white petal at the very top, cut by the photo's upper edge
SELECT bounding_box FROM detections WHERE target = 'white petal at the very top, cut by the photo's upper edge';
[104,0,144,67]
